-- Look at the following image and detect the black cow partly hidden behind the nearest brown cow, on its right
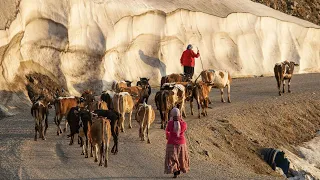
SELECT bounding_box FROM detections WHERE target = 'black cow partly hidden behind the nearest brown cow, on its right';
[93,110,120,154]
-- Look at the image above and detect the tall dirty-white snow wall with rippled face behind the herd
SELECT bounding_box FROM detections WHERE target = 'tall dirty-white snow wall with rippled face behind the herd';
[0,0,320,94]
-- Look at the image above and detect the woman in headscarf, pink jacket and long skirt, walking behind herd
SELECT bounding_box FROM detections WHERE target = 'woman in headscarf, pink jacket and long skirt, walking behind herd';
[164,108,190,178]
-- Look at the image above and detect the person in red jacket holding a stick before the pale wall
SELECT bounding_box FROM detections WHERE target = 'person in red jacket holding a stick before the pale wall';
[180,44,200,78]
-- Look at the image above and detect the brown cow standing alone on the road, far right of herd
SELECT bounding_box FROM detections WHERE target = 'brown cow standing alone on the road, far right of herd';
[274,61,299,96]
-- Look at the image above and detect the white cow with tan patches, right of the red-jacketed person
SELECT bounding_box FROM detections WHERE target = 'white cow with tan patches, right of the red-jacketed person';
[200,70,232,104]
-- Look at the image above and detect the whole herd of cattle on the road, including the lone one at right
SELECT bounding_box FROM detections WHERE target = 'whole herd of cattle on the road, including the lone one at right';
[31,61,295,167]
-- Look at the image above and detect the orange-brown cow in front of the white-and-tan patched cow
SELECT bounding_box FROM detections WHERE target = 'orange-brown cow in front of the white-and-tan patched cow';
[190,82,212,119]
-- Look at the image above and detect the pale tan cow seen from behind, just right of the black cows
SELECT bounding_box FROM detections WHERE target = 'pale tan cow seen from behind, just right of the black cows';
[113,92,134,132]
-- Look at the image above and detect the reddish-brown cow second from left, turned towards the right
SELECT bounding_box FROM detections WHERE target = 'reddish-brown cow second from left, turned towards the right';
[54,96,80,136]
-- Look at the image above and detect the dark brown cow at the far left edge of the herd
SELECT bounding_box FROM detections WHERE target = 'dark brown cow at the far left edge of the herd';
[31,100,50,141]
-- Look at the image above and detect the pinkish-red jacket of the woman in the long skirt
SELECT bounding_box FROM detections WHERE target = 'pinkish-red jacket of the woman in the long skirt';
[166,119,187,144]
